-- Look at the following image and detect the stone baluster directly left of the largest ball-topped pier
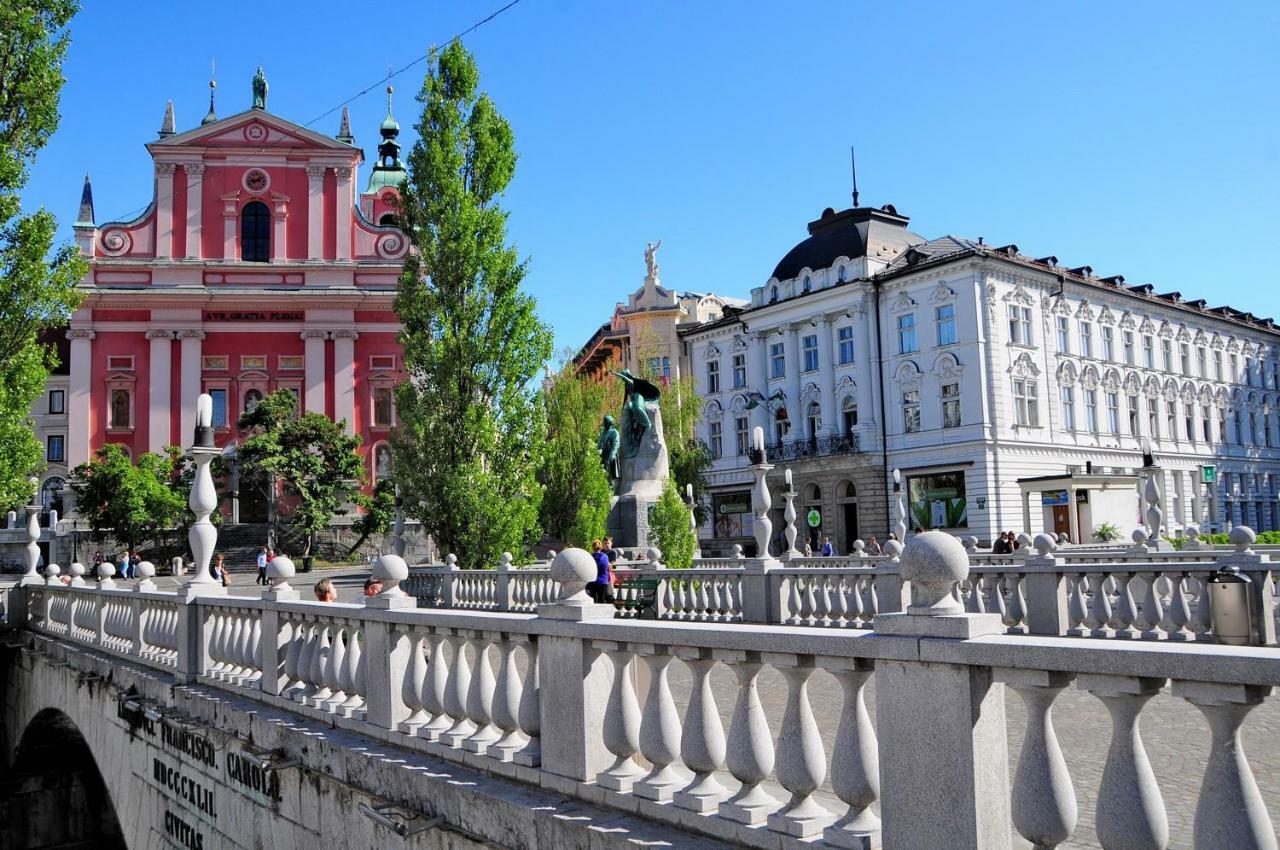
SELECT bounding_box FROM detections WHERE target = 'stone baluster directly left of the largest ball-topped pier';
[822,658,881,850]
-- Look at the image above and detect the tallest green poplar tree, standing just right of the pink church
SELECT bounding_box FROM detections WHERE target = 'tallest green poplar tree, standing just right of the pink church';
[393,41,550,567]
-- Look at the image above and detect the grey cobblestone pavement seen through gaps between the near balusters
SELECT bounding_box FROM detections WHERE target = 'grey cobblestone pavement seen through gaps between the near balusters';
[157,570,1280,850]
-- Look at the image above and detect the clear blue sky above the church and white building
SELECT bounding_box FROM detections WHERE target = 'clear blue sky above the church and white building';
[26,0,1280,355]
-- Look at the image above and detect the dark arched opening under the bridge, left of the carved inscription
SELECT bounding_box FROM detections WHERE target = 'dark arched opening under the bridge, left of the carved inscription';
[0,708,128,850]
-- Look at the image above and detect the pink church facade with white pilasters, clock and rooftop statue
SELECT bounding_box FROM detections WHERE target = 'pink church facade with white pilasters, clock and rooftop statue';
[65,74,408,517]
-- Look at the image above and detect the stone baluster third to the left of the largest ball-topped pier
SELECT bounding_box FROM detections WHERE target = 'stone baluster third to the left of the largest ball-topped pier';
[714,649,780,826]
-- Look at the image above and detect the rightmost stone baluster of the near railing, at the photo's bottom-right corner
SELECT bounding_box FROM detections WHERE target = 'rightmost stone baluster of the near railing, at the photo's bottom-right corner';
[1172,681,1276,850]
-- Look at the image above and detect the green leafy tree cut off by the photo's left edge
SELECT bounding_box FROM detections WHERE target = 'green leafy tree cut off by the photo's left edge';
[0,0,86,506]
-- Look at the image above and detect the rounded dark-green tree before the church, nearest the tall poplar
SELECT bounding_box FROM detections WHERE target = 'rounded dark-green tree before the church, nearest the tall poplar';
[237,389,367,557]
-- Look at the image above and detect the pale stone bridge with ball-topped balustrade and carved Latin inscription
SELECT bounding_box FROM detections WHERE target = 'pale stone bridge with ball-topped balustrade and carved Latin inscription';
[0,533,1280,850]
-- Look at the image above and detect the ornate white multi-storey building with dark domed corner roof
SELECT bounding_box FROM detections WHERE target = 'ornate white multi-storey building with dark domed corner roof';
[681,206,1280,552]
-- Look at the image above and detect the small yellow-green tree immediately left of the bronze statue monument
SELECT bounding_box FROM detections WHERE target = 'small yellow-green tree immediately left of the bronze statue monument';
[538,362,621,545]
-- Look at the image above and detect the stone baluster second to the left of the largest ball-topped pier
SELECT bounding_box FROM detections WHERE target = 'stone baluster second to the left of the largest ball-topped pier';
[764,653,832,840]
